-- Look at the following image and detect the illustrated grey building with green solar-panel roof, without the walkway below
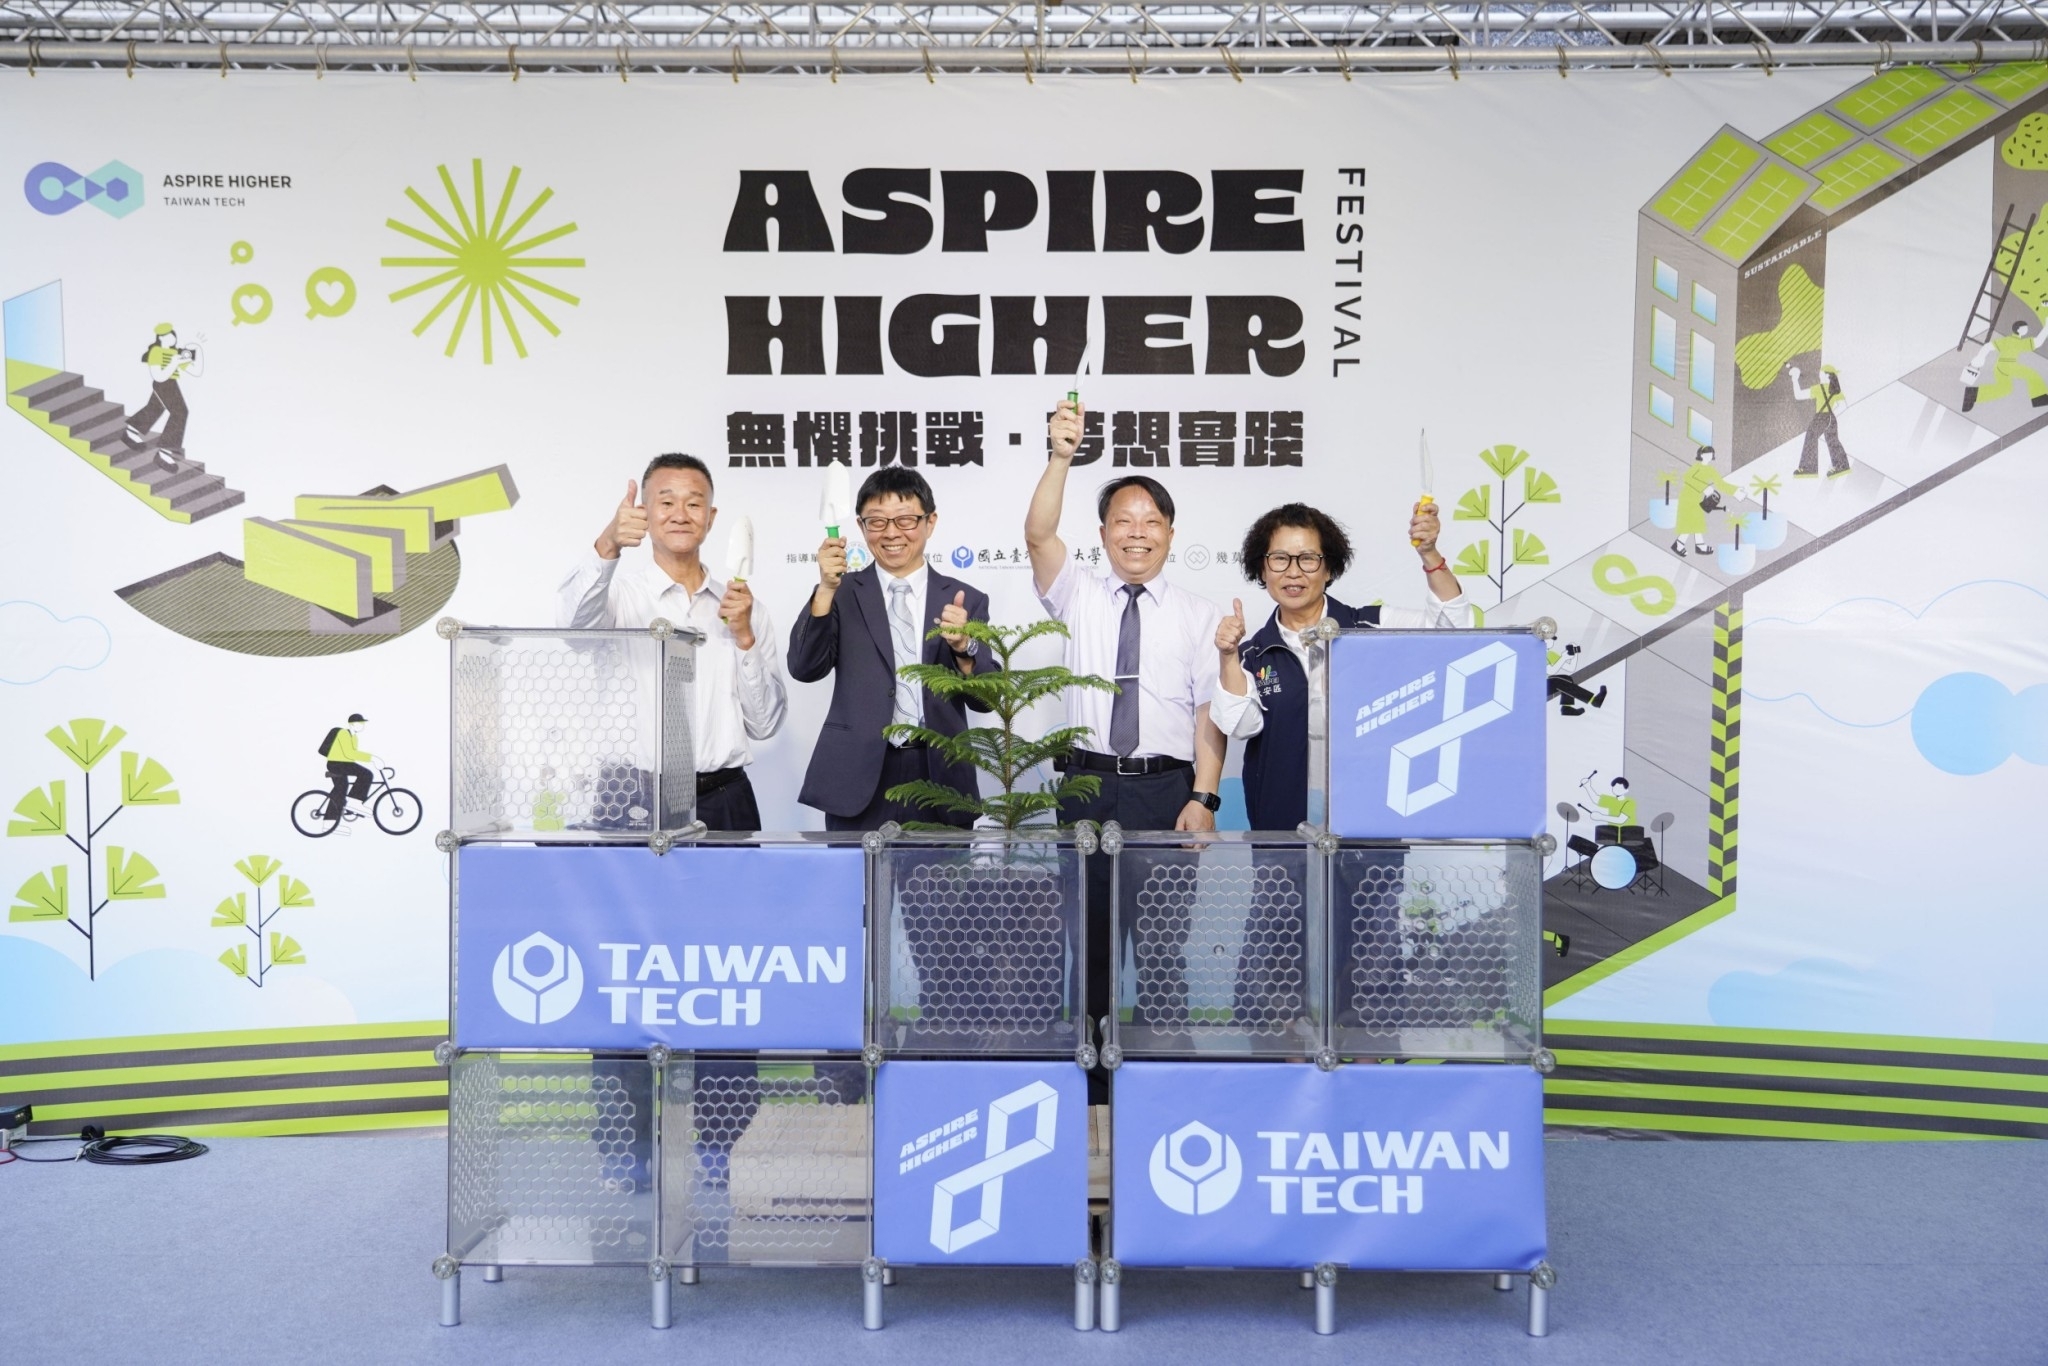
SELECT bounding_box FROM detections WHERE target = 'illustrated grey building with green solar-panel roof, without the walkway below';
[1630,63,2048,505]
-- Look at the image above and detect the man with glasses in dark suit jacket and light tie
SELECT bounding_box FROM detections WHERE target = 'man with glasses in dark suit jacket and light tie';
[788,465,989,829]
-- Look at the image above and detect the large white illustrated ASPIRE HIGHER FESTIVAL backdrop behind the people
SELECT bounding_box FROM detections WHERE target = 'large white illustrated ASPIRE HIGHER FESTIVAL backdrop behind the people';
[0,66,2048,1139]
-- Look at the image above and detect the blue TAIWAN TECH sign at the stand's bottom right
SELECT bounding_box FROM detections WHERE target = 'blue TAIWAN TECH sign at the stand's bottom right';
[1112,1063,1546,1272]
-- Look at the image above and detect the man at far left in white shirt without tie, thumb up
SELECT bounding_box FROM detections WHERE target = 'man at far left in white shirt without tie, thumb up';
[557,455,788,831]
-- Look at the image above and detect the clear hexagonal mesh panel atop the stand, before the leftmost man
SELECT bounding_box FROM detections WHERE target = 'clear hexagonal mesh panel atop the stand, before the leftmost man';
[453,631,696,838]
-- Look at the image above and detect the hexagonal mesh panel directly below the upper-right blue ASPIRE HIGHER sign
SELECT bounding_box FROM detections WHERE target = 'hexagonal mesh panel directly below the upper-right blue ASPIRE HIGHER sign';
[1331,846,1542,1057]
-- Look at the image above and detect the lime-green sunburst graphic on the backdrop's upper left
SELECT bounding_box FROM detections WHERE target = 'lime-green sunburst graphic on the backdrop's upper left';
[383,158,584,365]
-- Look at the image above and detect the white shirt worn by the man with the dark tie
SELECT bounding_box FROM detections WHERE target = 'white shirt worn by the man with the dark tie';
[1038,559,1223,764]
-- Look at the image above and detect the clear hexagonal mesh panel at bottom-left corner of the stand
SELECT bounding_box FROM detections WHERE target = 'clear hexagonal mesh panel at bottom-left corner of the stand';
[449,1053,655,1266]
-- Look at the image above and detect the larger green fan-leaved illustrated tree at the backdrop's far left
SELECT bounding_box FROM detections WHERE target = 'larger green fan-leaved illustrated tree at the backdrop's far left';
[6,717,178,979]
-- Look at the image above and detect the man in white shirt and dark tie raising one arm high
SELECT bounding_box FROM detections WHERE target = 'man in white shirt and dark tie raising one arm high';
[1024,399,1227,1056]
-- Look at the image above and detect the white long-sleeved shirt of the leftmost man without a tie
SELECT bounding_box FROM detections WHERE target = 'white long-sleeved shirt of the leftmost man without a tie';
[555,551,788,772]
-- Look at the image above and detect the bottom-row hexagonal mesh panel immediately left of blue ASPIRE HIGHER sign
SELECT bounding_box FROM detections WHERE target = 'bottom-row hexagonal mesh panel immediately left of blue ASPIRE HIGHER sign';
[662,1057,870,1266]
